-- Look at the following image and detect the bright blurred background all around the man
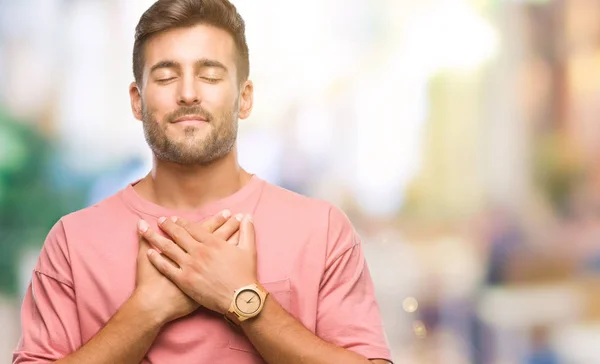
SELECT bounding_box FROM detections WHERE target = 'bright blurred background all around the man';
[0,0,600,364]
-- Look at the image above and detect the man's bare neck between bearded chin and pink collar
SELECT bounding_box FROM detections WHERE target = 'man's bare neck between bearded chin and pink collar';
[134,148,252,211]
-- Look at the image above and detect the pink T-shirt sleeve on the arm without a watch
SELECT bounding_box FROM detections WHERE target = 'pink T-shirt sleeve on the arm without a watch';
[13,222,81,364]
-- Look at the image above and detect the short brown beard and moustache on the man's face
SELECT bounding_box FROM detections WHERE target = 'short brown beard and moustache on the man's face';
[142,100,238,166]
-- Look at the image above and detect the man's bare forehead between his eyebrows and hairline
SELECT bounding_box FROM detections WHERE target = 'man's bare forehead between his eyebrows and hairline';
[144,24,235,70]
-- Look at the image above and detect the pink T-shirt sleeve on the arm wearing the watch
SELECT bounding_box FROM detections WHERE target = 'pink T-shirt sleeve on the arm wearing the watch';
[316,208,391,362]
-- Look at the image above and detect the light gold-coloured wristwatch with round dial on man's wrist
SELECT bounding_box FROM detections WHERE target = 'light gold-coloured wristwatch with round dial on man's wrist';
[225,284,269,326]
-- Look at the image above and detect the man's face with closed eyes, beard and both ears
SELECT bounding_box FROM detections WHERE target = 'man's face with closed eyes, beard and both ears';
[130,25,252,165]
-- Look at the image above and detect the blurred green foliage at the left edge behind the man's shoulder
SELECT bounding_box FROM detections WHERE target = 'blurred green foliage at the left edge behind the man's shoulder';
[0,109,85,296]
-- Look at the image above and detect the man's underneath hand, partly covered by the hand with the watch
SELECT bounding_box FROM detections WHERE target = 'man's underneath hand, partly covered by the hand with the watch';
[131,210,241,325]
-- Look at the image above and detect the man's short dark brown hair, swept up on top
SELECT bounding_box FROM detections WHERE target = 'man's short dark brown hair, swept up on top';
[133,0,250,83]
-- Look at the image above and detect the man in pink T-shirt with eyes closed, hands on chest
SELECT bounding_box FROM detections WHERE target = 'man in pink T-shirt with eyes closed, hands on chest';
[13,0,390,364]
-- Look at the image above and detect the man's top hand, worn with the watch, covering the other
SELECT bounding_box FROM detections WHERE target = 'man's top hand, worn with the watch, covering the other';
[146,216,258,314]
